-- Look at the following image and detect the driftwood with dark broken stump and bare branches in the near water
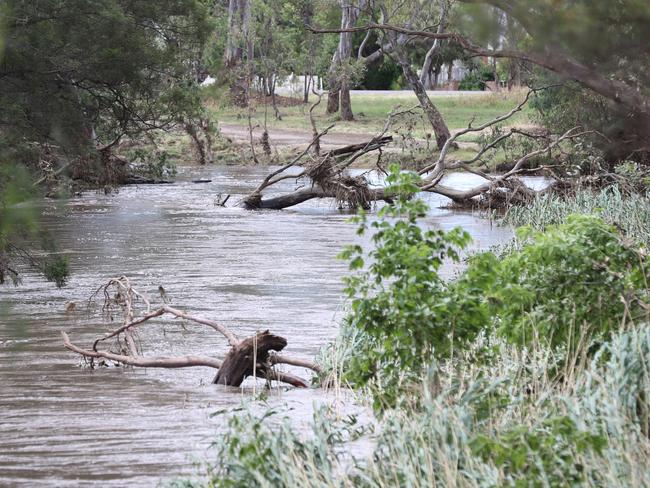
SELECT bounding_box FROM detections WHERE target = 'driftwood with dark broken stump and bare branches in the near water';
[61,277,320,388]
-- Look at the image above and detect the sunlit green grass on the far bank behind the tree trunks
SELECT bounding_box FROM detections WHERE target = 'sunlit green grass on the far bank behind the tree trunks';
[205,89,529,137]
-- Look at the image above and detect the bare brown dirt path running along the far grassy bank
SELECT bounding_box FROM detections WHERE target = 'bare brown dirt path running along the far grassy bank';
[219,124,375,149]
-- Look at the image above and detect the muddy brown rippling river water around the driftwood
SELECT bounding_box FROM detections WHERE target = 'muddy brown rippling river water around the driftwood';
[0,167,544,487]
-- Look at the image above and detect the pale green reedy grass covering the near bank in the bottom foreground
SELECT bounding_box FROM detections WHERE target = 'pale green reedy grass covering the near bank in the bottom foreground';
[173,324,650,488]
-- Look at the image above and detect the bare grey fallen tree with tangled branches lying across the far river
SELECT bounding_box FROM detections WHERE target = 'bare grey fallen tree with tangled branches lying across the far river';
[241,87,594,210]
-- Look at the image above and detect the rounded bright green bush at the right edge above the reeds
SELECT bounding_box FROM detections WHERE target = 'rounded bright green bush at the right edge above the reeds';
[478,216,647,351]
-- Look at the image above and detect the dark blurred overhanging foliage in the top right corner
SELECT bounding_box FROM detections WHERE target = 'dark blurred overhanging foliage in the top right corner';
[459,0,650,163]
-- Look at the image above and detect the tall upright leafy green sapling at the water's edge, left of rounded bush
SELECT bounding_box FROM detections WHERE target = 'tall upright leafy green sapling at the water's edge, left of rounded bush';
[340,166,482,402]
